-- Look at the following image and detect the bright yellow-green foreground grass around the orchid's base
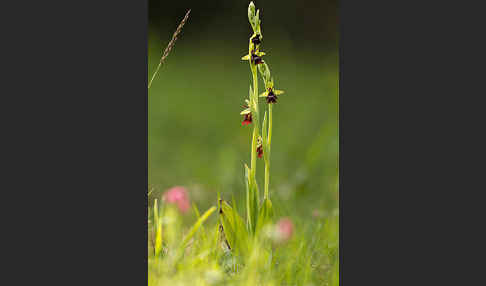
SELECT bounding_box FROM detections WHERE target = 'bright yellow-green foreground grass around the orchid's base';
[148,202,339,286]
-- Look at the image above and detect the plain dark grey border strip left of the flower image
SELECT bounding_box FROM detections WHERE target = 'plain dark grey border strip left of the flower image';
[1,0,148,285]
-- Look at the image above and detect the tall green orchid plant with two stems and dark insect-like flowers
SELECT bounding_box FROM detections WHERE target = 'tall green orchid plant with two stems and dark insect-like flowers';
[220,2,284,252]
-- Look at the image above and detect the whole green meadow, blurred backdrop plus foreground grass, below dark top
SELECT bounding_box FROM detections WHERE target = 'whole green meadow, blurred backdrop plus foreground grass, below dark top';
[148,9,339,286]
